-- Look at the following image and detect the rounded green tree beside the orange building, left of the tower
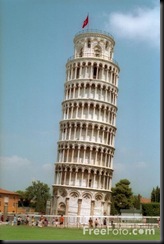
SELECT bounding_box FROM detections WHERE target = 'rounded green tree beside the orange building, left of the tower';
[26,181,51,213]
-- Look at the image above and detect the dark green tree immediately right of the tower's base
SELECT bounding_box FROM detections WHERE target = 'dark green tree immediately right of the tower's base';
[112,179,133,214]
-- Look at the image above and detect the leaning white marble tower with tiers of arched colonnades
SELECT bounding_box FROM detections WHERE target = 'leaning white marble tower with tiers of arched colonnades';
[52,30,120,219]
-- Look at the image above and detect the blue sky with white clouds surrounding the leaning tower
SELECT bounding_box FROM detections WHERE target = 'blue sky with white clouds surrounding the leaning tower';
[0,0,160,197]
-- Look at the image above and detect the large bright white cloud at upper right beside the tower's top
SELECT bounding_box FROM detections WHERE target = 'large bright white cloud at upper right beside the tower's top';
[105,5,160,47]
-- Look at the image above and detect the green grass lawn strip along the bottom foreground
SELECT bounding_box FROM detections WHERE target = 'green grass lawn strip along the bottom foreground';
[0,225,160,241]
